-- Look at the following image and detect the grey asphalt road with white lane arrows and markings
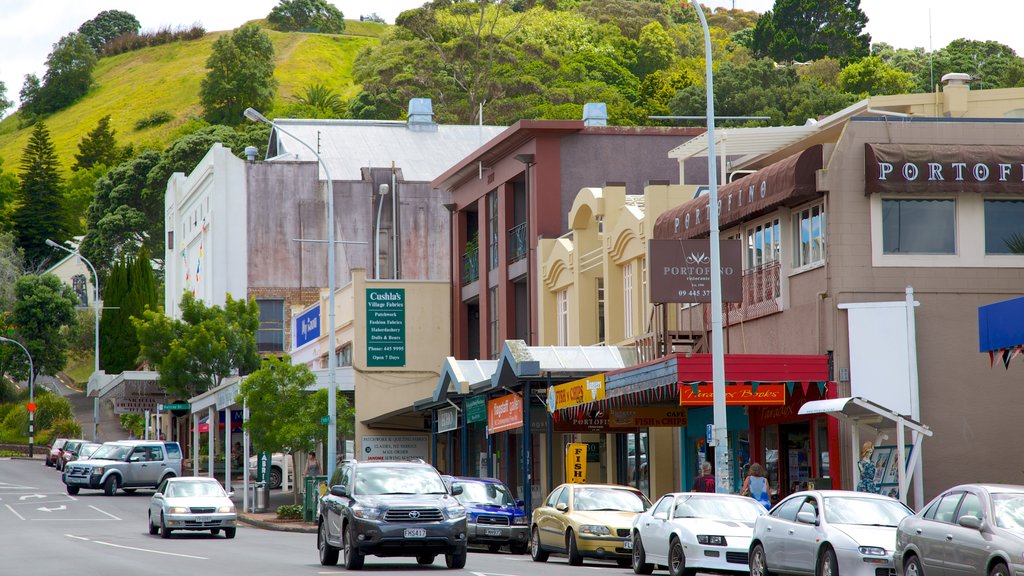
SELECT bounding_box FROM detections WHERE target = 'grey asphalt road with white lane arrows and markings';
[0,459,647,576]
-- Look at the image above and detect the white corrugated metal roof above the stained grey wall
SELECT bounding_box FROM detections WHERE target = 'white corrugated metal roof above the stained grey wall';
[267,118,505,181]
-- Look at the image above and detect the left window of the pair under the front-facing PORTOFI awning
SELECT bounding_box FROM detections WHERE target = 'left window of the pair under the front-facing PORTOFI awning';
[882,199,956,254]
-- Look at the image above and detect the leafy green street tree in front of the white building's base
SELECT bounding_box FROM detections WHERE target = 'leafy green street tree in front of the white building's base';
[132,292,259,398]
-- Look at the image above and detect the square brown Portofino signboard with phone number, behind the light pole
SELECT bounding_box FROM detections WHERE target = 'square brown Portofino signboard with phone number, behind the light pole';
[647,239,743,303]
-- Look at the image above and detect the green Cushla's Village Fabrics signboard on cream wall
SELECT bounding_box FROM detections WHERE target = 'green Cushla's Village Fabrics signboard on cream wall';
[367,288,406,367]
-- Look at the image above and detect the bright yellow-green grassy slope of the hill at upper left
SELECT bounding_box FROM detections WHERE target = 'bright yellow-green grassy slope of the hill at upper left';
[0,20,387,173]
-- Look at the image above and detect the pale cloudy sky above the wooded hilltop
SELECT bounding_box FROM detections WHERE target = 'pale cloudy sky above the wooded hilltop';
[0,0,1024,112]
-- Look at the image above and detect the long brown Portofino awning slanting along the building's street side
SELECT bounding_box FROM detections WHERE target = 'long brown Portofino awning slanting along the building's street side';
[654,145,822,240]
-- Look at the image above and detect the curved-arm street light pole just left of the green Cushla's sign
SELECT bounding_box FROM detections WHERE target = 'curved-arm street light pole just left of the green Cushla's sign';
[243,108,366,479]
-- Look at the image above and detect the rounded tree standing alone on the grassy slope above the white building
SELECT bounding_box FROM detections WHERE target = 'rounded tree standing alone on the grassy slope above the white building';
[200,24,278,126]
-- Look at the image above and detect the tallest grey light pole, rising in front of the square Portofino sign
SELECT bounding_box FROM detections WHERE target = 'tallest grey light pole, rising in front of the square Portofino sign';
[691,0,732,492]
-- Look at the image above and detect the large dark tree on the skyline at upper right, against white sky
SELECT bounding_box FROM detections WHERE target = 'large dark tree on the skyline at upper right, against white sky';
[751,0,871,61]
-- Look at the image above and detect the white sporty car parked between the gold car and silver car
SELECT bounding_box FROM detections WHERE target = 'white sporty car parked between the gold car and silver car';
[632,492,767,576]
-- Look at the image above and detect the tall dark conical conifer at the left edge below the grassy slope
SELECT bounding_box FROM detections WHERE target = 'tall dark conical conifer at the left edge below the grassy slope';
[13,122,68,268]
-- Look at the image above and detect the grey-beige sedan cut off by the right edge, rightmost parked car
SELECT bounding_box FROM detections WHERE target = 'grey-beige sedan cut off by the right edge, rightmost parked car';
[894,484,1024,576]
